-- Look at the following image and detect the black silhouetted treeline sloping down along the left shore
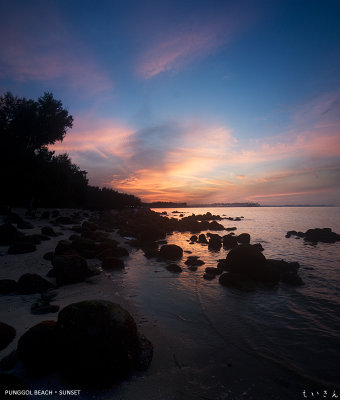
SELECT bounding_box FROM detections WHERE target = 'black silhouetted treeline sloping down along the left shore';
[0,92,141,209]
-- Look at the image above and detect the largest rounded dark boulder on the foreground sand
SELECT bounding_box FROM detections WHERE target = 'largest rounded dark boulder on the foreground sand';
[57,300,152,387]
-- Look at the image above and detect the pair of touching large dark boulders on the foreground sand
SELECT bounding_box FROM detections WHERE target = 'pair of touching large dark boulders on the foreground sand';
[0,300,153,387]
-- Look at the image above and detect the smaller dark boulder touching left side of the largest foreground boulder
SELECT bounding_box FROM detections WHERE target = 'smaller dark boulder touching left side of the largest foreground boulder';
[17,321,60,376]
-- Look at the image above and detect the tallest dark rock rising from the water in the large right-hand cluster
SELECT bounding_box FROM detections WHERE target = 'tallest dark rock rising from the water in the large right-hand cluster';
[226,244,280,284]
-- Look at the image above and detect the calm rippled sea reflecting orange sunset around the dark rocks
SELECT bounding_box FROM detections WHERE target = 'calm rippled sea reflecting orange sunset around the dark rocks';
[126,207,340,386]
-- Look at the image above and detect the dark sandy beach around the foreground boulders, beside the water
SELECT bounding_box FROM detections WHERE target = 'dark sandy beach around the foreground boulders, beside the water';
[0,209,314,400]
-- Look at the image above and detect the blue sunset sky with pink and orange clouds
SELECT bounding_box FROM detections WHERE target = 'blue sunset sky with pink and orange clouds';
[0,0,340,205]
